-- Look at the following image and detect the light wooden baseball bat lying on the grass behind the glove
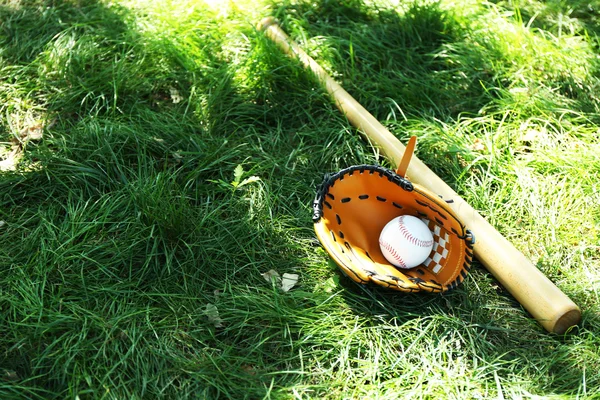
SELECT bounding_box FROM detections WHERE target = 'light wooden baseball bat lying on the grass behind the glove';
[258,17,581,334]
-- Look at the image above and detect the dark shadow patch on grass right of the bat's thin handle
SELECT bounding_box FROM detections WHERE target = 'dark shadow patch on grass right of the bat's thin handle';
[273,0,498,120]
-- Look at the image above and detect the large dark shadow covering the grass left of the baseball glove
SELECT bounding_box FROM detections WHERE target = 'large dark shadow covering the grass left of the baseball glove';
[0,1,326,398]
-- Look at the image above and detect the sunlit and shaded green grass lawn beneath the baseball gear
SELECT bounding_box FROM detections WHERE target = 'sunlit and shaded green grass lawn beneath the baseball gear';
[0,0,600,399]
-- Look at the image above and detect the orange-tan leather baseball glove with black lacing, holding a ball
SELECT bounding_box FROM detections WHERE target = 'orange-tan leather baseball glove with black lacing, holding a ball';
[313,159,475,292]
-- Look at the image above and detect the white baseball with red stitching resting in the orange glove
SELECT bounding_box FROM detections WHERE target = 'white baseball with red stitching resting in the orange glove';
[379,215,433,269]
